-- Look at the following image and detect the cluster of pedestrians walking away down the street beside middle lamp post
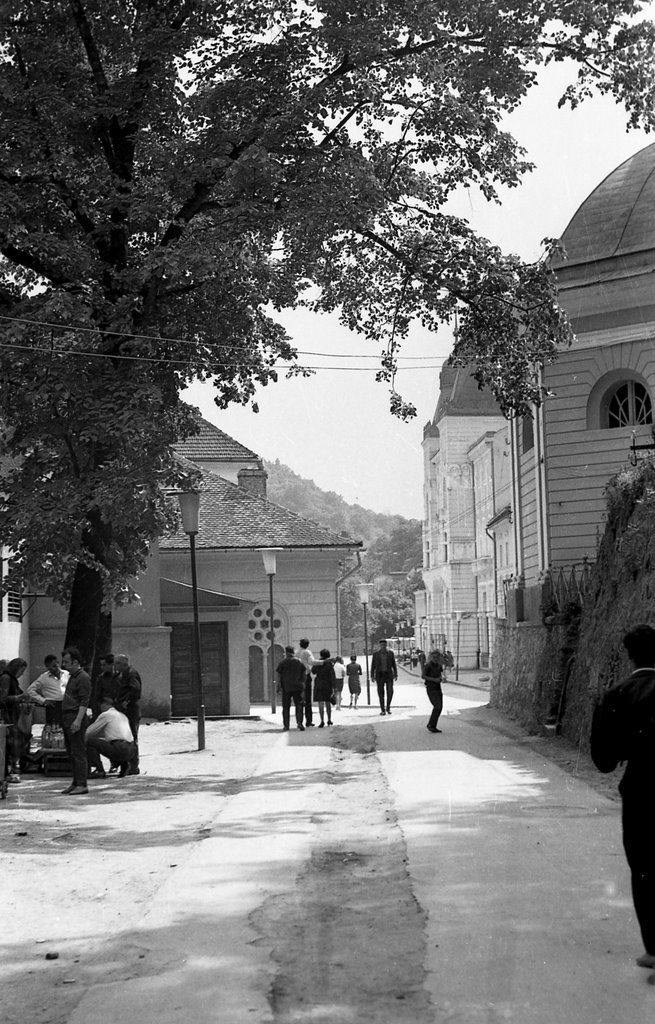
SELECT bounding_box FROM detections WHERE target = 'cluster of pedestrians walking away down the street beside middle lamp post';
[275,638,361,730]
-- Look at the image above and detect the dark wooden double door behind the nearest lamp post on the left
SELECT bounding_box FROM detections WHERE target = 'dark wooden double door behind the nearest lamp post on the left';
[170,623,229,718]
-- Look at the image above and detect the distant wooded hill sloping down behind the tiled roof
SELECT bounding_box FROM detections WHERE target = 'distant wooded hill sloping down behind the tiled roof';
[264,459,421,552]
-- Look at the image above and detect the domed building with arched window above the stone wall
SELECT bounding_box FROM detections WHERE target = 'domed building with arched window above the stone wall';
[512,143,655,588]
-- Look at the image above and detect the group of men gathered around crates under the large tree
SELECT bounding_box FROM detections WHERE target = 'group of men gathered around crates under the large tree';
[0,647,141,796]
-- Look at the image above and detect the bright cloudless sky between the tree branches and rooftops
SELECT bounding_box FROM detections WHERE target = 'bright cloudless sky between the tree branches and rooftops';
[184,48,655,519]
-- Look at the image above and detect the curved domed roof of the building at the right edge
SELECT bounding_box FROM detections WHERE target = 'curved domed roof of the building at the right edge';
[558,142,655,267]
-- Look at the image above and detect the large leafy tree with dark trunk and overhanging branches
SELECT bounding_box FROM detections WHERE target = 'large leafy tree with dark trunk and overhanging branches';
[0,0,655,657]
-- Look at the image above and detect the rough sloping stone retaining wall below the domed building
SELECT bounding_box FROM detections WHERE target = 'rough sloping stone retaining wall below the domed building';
[490,463,655,748]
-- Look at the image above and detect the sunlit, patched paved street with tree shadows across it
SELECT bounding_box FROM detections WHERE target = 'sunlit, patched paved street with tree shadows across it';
[0,673,655,1024]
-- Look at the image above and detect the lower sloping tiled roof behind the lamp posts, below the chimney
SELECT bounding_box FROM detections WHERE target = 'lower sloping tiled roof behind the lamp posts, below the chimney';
[160,472,362,551]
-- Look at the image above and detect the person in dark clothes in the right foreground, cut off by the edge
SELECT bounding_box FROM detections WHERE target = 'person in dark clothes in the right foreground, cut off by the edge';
[591,625,655,984]
